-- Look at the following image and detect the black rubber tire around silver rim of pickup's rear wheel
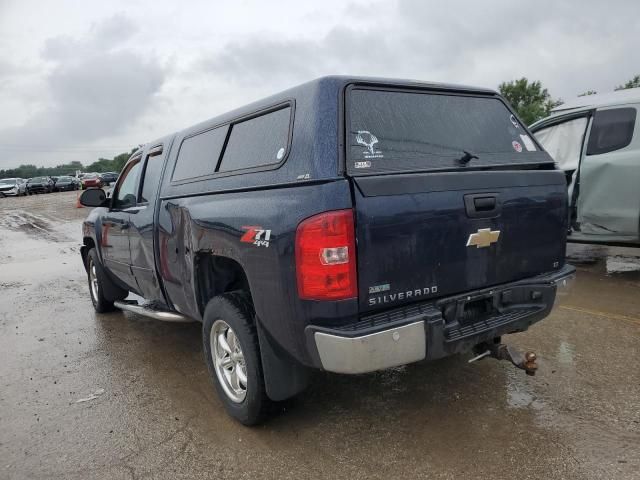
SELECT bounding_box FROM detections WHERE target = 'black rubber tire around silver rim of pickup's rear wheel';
[202,291,271,425]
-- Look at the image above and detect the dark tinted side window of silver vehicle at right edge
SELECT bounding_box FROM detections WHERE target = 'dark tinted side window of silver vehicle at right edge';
[587,108,636,155]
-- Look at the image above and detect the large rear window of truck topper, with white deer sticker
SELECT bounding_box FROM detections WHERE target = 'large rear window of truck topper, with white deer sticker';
[347,89,552,173]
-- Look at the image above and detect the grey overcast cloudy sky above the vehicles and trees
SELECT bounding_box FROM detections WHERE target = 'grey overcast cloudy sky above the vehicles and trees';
[0,0,640,169]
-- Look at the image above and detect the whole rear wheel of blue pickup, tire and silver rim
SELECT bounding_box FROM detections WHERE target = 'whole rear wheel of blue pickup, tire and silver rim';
[202,292,271,425]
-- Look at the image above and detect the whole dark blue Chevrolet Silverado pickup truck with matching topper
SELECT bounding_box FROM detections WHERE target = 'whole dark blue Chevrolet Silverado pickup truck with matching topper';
[81,77,574,424]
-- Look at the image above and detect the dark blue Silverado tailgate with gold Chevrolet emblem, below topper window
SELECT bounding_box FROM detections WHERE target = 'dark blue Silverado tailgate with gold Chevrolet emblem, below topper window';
[352,170,567,311]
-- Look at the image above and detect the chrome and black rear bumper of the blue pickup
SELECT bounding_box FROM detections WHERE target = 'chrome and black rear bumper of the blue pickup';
[308,266,575,374]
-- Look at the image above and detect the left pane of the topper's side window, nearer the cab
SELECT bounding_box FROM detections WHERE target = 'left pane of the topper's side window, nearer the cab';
[171,125,228,182]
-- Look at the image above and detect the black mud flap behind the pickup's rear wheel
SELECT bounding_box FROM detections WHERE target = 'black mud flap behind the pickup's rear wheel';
[256,320,309,402]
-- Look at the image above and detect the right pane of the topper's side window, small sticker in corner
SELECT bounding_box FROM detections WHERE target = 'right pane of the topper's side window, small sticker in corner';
[219,107,291,172]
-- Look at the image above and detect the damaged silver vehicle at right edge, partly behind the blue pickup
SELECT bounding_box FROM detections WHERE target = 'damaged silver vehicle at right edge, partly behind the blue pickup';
[531,88,640,246]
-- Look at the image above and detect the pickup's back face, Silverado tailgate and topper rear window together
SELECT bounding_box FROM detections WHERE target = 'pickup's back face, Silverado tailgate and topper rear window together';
[345,85,567,311]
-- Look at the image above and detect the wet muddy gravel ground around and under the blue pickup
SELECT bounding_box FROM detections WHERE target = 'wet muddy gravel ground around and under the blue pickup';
[0,192,640,480]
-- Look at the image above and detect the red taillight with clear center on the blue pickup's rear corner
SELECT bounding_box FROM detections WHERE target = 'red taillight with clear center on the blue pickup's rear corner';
[296,210,358,300]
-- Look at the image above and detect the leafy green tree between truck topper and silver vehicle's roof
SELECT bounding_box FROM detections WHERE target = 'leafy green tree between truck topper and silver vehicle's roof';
[498,77,562,125]
